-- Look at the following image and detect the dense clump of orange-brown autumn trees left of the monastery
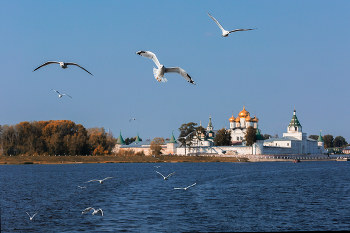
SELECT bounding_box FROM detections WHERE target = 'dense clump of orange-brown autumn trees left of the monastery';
[0,120,116,156]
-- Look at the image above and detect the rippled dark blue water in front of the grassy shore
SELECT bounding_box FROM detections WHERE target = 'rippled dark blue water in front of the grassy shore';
[0,161,350,232]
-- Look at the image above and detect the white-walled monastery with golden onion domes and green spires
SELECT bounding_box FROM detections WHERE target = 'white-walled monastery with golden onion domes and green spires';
[113,106,326,156]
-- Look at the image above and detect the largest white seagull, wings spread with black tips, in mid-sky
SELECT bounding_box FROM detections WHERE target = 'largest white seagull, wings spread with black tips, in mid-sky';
[136,51,196,85]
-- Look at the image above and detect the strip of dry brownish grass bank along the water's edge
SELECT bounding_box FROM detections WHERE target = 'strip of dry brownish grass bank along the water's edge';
[0,155,247,165]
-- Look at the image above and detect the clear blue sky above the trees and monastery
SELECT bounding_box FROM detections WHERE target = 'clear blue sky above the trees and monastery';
[0,0,350,142]
